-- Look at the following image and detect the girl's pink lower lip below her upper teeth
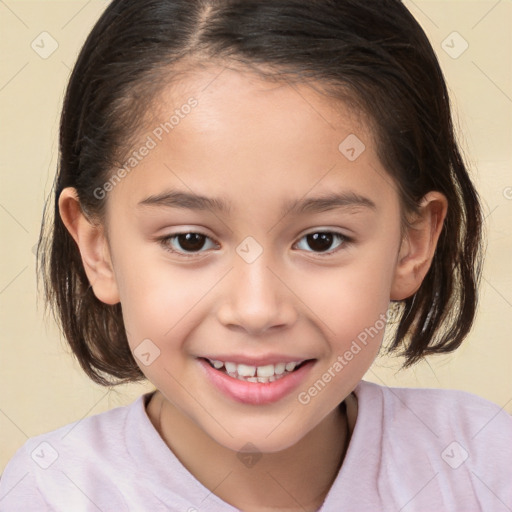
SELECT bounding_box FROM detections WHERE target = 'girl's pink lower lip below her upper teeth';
[199,359,315,405]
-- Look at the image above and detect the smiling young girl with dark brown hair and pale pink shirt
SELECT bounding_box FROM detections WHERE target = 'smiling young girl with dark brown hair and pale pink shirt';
[0,0,512,512]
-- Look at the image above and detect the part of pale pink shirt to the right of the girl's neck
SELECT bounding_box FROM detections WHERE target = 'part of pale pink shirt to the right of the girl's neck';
[322,381,512,512]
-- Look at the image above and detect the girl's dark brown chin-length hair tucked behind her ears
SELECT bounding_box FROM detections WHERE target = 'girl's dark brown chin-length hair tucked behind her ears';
[38,0,482,385]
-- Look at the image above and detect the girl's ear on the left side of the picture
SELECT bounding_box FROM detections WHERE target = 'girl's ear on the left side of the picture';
[59,187,120,304]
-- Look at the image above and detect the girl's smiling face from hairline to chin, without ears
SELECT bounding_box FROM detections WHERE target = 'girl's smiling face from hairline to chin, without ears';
[100,68,406,452]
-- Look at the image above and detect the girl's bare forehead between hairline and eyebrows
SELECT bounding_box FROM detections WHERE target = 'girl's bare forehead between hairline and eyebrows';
[106,63,394,216]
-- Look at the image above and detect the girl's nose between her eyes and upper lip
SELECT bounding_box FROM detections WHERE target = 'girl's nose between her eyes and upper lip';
[217,251,297,335]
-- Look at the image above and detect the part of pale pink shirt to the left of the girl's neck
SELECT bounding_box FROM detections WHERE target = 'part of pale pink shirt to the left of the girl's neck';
[0,393,230,512]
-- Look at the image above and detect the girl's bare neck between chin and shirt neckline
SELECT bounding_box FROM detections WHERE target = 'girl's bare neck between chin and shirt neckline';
[147,391,357,512]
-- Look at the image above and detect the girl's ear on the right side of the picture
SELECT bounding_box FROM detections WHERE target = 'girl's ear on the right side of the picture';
[390,191,448,300]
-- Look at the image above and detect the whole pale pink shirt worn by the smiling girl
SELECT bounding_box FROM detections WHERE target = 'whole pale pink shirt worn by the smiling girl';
[0,381,512,512]
